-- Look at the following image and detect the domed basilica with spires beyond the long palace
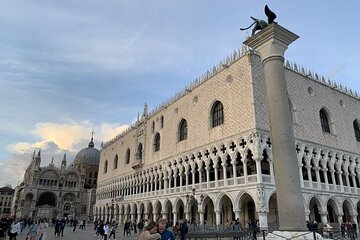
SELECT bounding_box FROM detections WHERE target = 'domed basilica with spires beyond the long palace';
[13,138,100,219]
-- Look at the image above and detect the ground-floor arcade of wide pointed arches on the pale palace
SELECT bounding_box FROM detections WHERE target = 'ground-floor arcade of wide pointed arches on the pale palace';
[94,184,360,230]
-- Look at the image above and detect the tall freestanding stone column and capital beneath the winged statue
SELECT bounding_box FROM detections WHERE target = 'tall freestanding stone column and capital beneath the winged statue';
[244,23,306,230]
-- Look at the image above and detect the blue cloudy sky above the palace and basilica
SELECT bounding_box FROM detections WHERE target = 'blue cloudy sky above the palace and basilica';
[0,0,360,187]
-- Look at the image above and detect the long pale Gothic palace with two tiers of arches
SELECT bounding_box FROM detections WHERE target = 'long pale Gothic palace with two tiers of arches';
[94,44,360,229]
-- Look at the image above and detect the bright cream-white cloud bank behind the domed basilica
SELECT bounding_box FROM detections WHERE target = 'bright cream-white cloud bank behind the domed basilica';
[0,120,128,186]
